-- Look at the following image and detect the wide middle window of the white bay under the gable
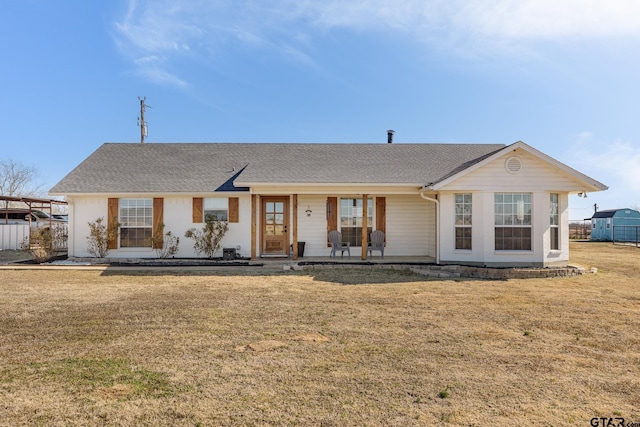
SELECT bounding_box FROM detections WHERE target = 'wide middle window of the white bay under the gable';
[494,193,532,251]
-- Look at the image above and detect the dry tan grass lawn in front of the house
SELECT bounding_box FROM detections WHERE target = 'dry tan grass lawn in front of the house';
[0,243,640,426]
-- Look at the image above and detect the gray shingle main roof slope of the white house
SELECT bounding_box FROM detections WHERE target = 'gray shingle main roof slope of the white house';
[50,143,505,194]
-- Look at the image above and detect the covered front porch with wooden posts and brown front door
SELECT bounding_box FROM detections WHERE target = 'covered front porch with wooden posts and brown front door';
[250,188,437,264]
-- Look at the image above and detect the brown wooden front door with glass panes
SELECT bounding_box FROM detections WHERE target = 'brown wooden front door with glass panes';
[261,197,289,256]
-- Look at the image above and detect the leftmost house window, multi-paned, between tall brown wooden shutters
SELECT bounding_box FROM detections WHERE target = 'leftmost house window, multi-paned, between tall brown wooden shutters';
[118,199,153,248]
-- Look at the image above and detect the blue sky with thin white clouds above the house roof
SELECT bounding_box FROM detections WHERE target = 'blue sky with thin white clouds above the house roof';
[0,0,640,219]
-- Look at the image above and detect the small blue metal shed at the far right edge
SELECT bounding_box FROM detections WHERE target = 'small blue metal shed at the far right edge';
[591,208,640,242]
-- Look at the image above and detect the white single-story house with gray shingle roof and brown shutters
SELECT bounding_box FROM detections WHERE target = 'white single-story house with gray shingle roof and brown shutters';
[50,141,607,266]
